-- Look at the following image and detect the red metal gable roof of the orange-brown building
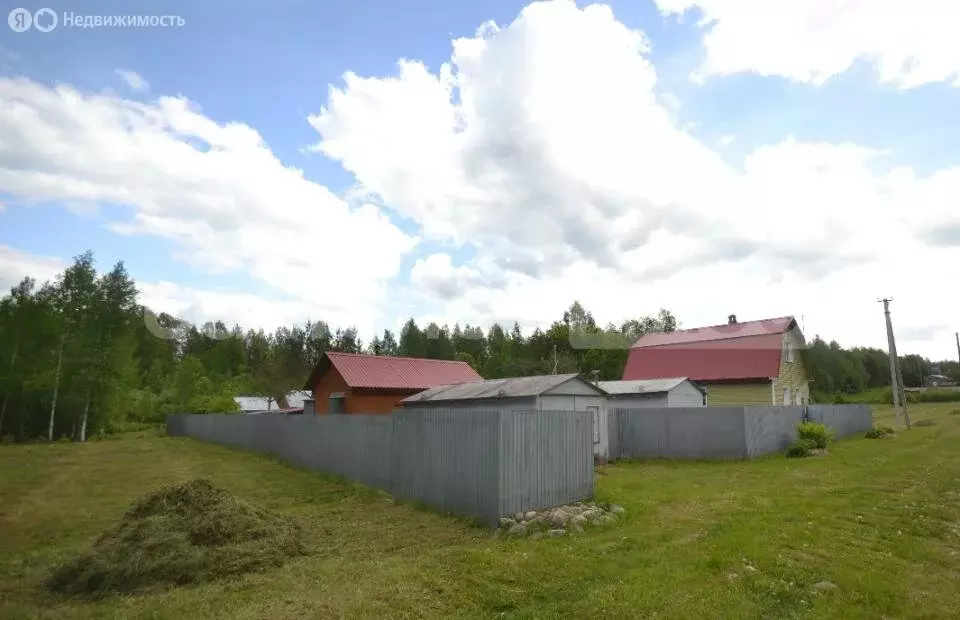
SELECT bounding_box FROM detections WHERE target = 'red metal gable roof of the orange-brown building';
[303,351,483,390]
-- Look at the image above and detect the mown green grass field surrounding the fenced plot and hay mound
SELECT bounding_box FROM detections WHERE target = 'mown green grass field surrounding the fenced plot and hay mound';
[0,404,960,618]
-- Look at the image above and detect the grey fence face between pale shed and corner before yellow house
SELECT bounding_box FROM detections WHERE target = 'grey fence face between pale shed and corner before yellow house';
[616,407,747,459]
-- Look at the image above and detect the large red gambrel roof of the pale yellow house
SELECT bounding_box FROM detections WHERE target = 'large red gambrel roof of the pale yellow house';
[623,317,796,381]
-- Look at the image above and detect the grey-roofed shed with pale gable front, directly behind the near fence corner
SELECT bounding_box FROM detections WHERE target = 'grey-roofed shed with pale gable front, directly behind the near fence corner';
[400,374,609,457]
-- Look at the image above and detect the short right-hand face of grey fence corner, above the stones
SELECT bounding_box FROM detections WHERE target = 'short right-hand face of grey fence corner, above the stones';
[498,411,594,514]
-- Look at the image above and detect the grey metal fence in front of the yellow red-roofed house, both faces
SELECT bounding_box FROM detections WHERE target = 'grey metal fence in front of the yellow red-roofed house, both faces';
[610,405,873,459]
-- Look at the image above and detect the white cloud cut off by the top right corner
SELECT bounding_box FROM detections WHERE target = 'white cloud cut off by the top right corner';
[654,0,960,89]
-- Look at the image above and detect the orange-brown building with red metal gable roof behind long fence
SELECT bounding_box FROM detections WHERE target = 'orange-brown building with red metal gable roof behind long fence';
[303,352,483,414]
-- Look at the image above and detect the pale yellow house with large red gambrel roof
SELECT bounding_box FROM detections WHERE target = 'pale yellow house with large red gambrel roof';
[623,315,810,406]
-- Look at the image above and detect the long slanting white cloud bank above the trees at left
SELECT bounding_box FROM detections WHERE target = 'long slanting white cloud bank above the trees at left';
[0,79,416,334]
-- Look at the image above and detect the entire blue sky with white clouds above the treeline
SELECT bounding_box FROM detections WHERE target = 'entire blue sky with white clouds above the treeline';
[0,0,960,359]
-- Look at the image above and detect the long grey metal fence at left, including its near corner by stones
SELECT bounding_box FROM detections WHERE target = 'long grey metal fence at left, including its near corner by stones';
[167,409,593,523]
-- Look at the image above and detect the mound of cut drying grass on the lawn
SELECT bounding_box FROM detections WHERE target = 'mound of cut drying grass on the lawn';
[47,480,304,595]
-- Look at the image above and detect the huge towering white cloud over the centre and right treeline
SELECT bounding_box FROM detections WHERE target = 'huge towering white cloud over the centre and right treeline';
[310,1,960,356]
